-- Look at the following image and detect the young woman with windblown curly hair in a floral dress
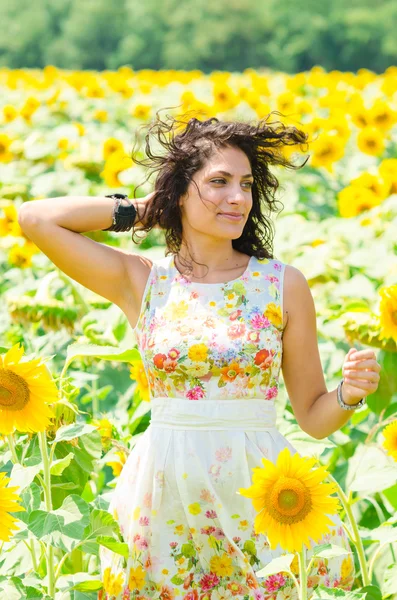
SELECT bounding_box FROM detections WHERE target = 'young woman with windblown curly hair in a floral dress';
[20,117,380,600]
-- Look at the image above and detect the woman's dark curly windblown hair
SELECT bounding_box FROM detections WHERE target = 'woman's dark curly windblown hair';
[131,111,309,272]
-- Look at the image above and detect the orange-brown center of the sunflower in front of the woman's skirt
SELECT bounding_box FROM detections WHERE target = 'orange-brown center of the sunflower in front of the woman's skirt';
[268,476,312,524]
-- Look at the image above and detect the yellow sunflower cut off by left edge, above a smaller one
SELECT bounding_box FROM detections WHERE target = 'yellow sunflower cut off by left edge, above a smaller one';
[0,344,58,435]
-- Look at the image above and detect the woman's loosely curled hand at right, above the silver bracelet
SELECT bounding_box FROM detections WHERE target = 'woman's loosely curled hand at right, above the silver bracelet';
[342,348,381,402]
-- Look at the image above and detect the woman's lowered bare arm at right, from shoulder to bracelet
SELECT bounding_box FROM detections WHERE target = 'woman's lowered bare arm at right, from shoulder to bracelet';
[282,265,357,439]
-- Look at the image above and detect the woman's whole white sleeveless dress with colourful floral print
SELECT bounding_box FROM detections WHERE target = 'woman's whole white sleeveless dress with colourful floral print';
[99,255,354,600]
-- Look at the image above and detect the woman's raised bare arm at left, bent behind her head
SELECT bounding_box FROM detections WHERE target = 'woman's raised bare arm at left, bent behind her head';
[18,196,151,308]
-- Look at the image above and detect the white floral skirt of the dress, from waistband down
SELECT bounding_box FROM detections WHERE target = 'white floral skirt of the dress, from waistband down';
[100,397,354,600]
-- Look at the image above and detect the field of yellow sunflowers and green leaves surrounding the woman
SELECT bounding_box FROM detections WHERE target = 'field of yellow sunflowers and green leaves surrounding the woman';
[0,66,397,600]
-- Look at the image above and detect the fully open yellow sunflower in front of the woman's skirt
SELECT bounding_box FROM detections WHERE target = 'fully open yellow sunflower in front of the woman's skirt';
[238,448,340,552]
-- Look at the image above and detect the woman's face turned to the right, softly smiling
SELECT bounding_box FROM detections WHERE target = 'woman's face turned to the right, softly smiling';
[179,146,253,239]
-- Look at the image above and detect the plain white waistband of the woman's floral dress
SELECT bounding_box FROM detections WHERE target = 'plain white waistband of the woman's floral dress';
[150,396,276,431]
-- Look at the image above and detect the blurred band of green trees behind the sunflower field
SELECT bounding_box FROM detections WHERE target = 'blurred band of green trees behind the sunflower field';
[0,0,397,72]
